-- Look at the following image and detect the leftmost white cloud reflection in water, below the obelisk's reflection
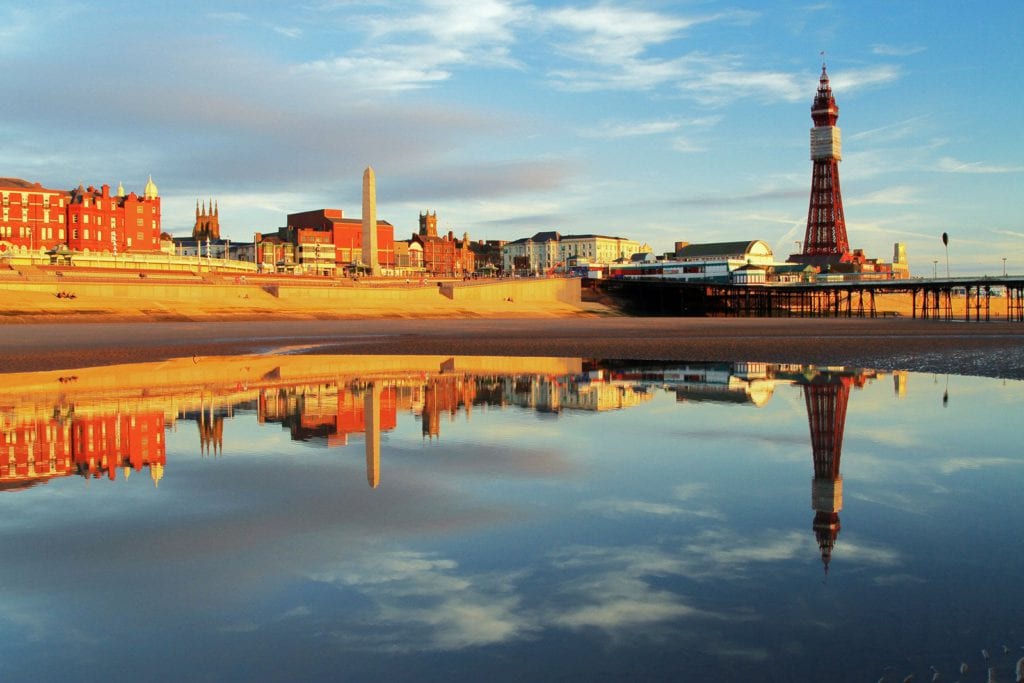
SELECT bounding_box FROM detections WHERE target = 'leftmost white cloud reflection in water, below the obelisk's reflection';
[312,551,535,650]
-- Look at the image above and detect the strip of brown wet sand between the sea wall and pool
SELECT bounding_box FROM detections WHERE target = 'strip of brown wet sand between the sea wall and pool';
[0,317,1024,379]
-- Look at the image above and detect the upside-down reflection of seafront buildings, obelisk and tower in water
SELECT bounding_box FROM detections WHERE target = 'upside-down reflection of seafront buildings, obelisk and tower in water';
[0,359,888,571]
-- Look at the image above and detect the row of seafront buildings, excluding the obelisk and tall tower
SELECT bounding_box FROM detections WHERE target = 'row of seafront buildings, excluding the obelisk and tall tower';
[0,171,905,284]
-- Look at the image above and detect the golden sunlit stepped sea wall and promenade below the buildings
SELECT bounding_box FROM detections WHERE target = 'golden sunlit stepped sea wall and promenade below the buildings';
[0,265,590,324]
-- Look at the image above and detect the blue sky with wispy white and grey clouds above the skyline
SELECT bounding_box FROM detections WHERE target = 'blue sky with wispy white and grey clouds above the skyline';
[0,0,1024,275]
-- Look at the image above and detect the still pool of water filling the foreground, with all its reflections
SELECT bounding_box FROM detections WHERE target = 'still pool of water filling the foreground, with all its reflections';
[0,355,1024,681]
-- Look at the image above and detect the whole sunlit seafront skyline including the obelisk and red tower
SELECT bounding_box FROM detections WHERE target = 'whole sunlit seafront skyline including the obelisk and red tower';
[0,65,909,285]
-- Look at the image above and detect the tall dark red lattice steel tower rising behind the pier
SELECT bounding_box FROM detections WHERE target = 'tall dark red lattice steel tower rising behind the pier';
[803,63,851,262]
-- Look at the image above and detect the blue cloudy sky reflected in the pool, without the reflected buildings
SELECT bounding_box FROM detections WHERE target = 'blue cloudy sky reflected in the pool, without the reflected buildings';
[0,366,1024,681]
